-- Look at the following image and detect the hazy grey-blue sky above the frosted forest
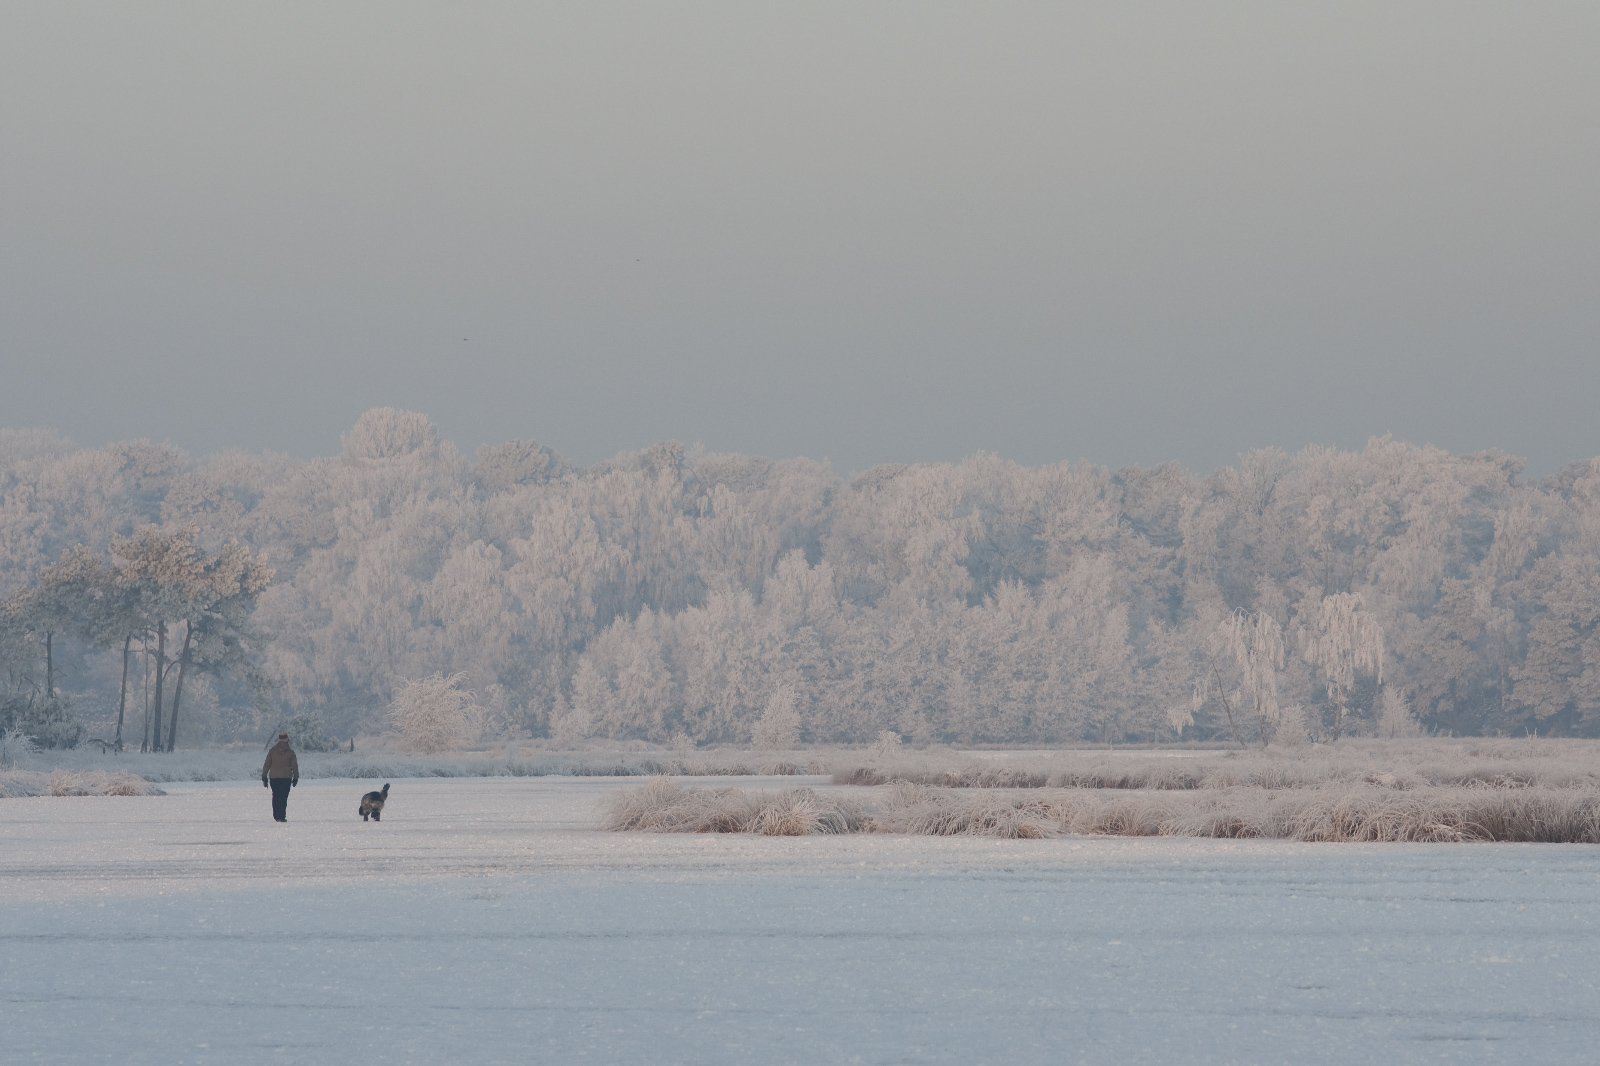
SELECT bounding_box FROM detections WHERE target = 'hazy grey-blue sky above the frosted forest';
[0,0,1600,474]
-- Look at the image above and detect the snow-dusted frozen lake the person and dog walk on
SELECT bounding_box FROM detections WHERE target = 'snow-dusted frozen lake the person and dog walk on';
[0,778,1600,1066]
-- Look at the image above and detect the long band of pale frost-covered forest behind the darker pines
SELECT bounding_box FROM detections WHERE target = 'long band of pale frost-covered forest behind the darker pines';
[0,408,1600,746]
